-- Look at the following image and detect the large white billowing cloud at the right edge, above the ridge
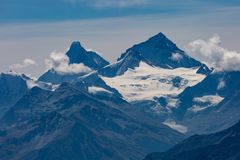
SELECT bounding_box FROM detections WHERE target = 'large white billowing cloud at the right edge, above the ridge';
[187,35,240,71]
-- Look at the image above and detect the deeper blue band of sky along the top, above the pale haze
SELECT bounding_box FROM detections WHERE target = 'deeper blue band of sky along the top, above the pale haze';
[0,0,240,23]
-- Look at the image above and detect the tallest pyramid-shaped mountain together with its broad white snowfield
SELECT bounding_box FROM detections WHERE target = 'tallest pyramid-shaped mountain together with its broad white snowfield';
[94,33,211,102]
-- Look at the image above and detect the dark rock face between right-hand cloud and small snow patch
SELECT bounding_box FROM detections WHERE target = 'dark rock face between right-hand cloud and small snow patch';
[175,71,240,114]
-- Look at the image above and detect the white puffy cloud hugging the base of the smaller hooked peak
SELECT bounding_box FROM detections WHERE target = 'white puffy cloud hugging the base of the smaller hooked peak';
[45,52,91,74]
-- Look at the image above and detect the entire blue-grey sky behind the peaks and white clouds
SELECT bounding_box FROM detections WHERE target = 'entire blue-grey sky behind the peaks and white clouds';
[0,0,240,76]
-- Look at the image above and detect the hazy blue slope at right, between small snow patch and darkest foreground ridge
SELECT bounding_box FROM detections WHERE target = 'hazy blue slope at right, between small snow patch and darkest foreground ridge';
[178,91,240,135]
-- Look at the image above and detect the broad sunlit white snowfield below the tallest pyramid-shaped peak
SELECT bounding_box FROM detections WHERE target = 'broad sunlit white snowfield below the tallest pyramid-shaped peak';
[101,62,205,102]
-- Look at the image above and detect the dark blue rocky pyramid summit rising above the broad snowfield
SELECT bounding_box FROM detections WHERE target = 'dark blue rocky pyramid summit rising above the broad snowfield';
[118,32,206,68]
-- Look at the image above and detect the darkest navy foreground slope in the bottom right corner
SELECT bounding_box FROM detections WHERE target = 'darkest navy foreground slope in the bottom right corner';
[144,122,240,160]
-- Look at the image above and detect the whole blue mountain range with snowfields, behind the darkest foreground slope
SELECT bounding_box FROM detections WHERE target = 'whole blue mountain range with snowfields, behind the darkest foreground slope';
[0,33,240,160]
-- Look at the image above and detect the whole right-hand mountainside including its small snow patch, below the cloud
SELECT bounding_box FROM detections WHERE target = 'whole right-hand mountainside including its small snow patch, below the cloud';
[170,71,240,134]
